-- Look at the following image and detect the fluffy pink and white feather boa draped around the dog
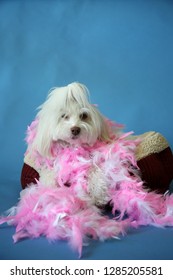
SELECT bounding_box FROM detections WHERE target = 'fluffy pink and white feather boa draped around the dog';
[0,121,173,255]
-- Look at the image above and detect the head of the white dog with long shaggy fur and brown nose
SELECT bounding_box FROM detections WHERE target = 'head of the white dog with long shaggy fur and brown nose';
[33,82,110,156]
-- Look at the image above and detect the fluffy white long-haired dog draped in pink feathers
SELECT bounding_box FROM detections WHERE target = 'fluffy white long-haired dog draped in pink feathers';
[25,82,119,205]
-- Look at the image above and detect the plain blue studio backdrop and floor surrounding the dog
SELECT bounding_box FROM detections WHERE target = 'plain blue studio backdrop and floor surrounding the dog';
[0,0,173,259]
